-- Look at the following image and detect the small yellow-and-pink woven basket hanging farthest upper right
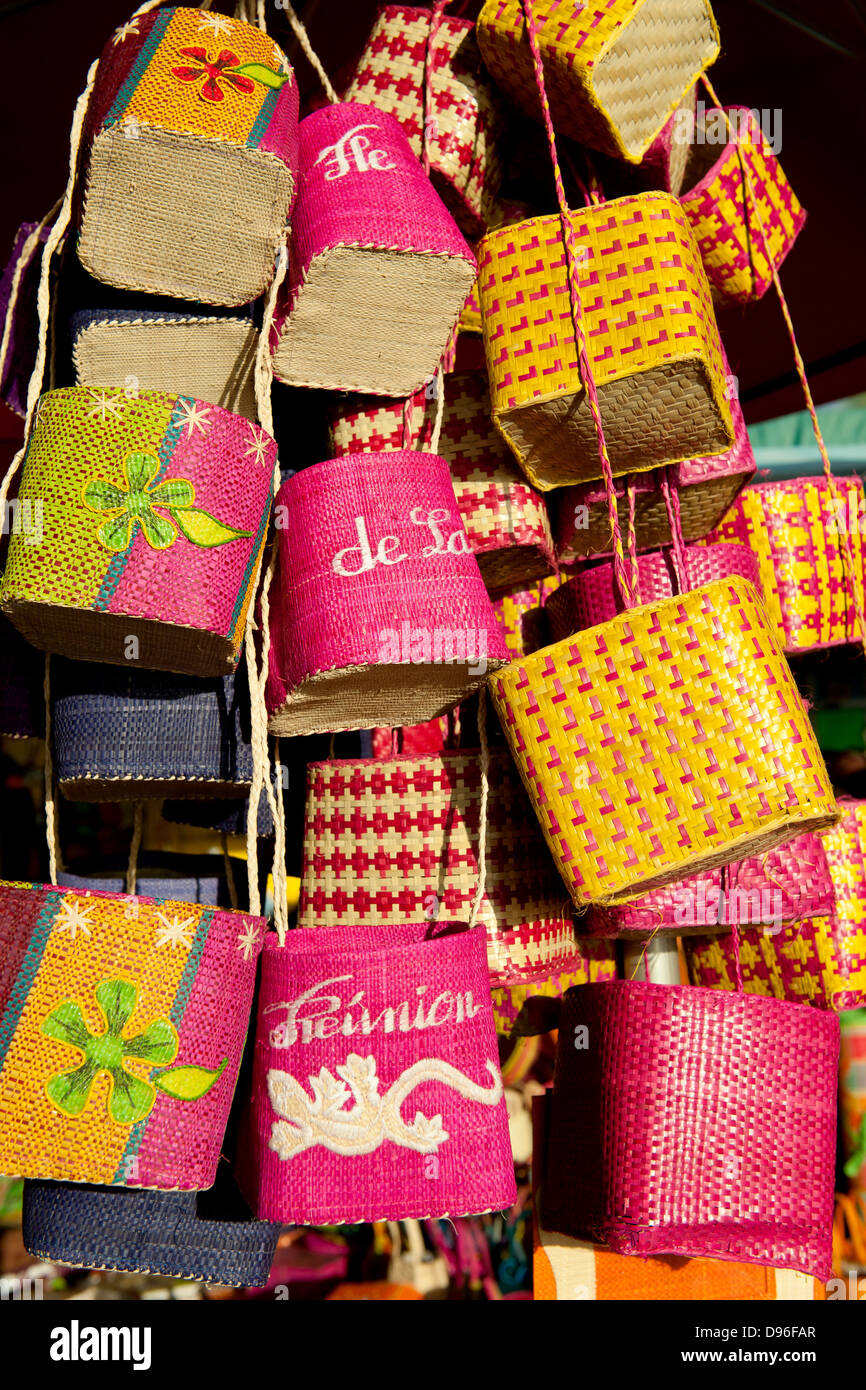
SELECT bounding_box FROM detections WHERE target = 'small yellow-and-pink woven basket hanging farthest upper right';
[680,106,806,304]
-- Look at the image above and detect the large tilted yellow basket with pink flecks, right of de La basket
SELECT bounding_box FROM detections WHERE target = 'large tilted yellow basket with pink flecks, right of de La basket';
[489,577,838,906]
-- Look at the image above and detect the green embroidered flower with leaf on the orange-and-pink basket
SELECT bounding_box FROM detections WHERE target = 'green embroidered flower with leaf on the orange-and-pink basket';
[42,980,228,1125]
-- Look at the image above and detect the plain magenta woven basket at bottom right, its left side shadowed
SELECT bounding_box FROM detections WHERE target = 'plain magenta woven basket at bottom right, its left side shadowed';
[542,980,840,1283]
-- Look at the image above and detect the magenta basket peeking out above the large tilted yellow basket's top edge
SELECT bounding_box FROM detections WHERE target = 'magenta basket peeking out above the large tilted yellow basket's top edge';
[545,543,760,642]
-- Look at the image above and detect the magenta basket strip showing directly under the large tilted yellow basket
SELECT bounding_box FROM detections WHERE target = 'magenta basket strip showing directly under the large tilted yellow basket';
[578,834,835,939]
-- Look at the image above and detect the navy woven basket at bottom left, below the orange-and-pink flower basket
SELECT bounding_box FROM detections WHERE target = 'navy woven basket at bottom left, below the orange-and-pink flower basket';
[22,1182,281,1289]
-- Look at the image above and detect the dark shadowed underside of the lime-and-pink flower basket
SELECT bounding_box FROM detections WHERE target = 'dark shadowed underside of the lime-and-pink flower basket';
[3,598,239,676]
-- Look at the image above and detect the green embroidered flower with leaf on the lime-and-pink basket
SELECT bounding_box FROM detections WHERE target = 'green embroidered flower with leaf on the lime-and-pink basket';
[82,453,253,550]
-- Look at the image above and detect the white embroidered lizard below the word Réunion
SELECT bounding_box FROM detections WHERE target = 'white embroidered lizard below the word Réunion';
[268,1052,503,1159]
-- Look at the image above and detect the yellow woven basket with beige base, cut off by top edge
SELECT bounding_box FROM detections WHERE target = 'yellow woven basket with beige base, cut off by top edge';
[477,0,719,163]
